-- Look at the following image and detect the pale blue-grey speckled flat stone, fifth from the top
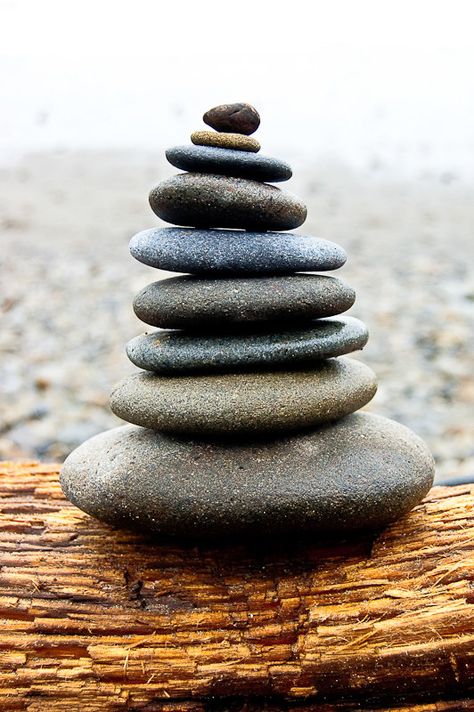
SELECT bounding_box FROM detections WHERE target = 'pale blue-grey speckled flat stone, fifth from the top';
[130,227,346,275]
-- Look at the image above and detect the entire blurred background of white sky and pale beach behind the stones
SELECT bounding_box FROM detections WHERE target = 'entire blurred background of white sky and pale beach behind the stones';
[0,0,474,478]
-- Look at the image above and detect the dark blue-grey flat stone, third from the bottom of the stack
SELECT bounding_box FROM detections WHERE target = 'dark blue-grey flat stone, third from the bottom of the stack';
[127,316,368,375]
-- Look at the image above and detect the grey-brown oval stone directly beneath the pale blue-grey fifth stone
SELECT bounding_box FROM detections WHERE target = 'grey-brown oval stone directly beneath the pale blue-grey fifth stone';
[133,274,355,329]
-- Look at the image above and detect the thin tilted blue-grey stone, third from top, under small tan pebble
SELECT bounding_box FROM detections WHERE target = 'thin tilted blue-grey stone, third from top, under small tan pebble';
[166,145,292,183]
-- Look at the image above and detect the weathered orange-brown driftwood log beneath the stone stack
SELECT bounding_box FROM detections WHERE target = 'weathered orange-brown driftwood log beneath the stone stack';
[0,463,474,712]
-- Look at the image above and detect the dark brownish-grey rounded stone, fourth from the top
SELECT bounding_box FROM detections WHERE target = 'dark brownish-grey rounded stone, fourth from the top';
[150,173,306,230]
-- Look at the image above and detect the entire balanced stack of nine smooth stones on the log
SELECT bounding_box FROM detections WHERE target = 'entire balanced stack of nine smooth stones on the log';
[61,104,433,538]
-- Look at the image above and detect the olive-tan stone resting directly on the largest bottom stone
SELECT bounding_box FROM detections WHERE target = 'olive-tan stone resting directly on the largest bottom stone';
[110,356,377,436]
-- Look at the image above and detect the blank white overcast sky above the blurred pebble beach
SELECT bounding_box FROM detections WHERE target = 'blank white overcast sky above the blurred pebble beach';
[0,0,474,177]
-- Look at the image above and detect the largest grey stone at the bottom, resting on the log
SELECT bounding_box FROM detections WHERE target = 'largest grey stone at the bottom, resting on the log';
[61,413,433,540]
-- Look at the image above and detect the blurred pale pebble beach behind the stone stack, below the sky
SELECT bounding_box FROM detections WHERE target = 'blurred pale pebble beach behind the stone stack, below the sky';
[0,153,474,477]
